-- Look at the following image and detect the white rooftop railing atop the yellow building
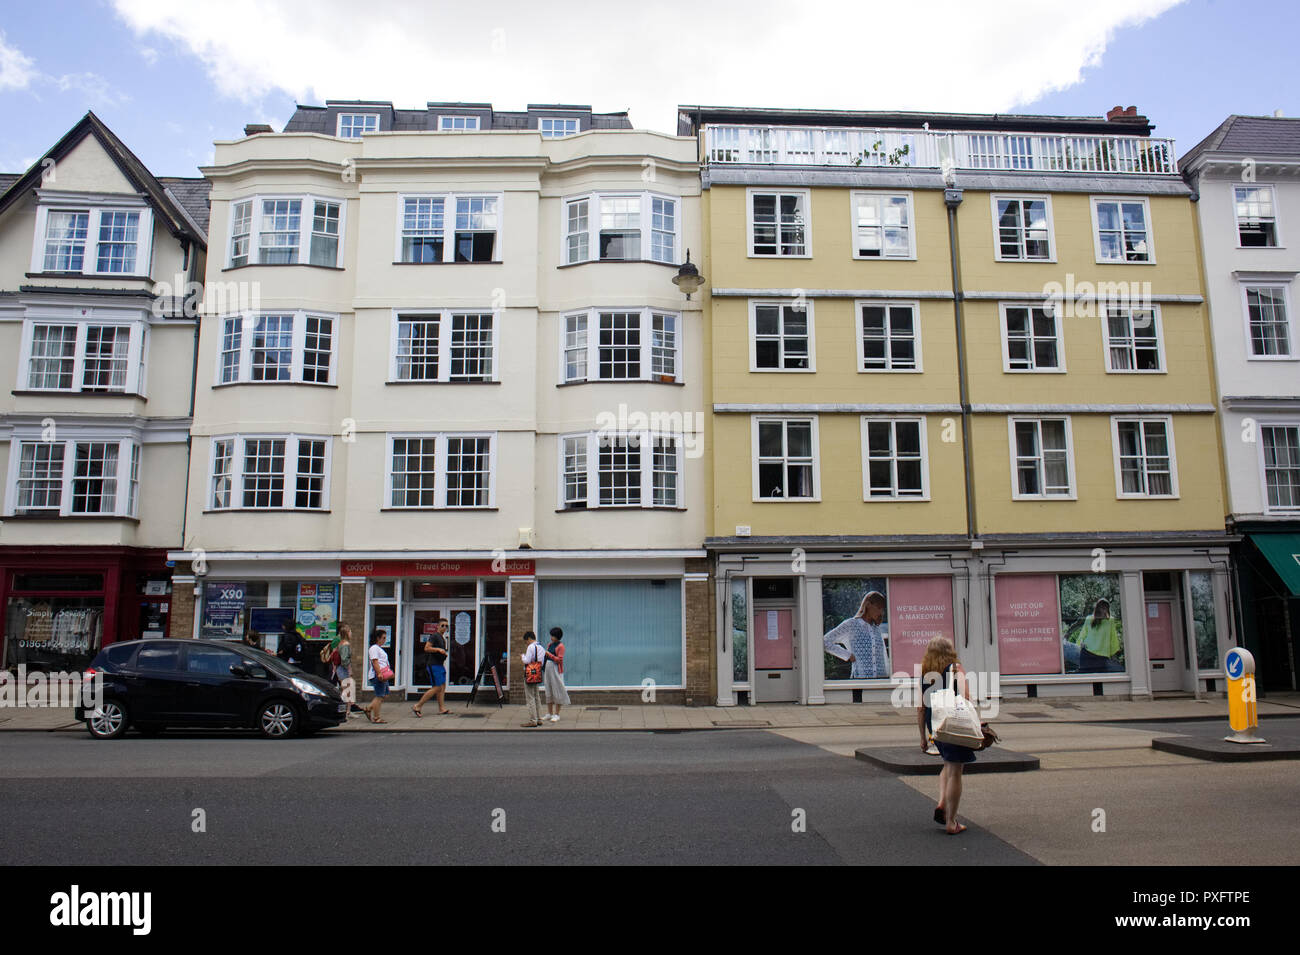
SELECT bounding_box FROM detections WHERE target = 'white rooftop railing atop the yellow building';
[705,123,1178,175]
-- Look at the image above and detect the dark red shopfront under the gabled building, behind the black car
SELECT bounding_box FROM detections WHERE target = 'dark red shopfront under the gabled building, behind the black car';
[0,547,172,672]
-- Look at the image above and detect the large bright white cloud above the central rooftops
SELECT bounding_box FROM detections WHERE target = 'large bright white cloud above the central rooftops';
[113,0,1183,131]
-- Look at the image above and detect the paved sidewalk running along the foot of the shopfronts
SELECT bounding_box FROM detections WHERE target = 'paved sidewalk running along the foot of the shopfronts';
[0,693,1300,733]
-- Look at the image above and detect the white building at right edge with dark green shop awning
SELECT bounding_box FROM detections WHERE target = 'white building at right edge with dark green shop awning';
[1180,116,1300,693]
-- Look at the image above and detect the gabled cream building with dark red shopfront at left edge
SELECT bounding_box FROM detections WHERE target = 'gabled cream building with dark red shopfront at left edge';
[0,113,208,670]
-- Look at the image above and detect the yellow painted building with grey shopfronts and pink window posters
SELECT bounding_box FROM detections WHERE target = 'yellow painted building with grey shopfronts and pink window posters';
[679,107,1230,706]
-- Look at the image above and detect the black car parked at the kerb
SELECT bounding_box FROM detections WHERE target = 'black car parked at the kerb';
[74,639,347,739]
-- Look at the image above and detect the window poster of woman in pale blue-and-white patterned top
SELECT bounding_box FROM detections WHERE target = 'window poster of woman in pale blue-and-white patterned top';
[822,577,891,681]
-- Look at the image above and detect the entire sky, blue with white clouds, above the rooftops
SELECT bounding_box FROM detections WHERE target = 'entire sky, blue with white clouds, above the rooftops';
[0,0,1300,175]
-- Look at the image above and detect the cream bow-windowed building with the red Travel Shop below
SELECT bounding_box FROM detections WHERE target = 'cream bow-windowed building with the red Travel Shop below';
[172,101,712,702]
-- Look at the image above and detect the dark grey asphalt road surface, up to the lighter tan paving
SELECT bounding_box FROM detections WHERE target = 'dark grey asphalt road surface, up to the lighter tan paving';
[0,730,1035,865]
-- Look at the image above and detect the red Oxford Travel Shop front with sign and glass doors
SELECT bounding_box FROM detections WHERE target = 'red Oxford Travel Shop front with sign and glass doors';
[339,559,534,694]
